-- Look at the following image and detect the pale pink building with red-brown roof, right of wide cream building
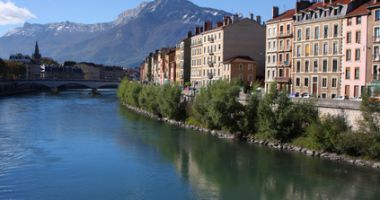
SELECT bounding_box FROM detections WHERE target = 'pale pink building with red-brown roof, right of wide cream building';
[341,3,369,98]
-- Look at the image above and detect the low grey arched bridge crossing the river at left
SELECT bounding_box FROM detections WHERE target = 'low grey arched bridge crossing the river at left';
[2,79,120,94]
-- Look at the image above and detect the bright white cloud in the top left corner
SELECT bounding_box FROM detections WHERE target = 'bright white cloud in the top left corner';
[0,1,36,25]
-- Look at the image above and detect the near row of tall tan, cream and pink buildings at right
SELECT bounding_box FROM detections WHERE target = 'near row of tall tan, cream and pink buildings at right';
[265,0,380,98]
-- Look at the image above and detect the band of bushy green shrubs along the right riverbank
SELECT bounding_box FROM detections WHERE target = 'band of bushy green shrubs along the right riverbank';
[118,80,380,159]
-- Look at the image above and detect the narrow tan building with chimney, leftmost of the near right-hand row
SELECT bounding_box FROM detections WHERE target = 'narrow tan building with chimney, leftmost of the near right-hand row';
[265,7,295,92]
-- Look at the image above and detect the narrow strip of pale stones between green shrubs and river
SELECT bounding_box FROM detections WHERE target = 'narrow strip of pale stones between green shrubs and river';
[123,103,380,170]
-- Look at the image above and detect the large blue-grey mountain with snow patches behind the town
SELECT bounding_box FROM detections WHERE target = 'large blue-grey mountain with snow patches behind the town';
[0,0,231,66]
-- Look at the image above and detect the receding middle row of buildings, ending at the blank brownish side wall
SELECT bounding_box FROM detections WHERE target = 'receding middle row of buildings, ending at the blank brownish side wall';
[140,15,265,87]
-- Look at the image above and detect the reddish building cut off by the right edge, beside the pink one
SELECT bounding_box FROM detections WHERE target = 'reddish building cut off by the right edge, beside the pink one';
[366,0,380,96]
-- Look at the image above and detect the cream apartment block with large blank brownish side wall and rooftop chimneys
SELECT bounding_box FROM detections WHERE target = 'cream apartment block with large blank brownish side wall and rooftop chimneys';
[191,15,265,87]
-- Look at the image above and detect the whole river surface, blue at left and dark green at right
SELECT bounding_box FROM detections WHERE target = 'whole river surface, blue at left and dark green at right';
[0,90,380,200]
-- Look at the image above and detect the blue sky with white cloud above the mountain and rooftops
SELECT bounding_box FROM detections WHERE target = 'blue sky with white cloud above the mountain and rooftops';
[0,0,296,36]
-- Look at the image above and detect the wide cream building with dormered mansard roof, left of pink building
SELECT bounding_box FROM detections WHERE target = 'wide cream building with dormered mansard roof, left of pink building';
[292,0,366,98]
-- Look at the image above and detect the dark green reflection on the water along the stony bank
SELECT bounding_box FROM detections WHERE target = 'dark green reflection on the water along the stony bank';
[119,106,380,199]
